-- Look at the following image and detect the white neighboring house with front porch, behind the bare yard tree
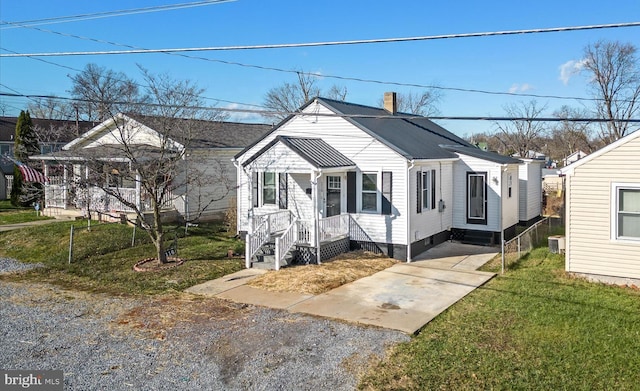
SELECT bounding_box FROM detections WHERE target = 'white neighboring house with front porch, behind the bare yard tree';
[31,114,271,221]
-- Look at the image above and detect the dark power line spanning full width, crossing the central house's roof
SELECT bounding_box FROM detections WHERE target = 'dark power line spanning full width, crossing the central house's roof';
[0,92,640,123]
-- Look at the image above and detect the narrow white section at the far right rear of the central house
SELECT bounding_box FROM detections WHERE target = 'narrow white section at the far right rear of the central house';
[518,159,544,226]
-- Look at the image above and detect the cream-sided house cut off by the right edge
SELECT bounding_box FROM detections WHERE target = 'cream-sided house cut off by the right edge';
[561,131,640,285]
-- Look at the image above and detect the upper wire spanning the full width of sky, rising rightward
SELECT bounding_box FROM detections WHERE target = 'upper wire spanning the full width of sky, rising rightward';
[0,22,640,58]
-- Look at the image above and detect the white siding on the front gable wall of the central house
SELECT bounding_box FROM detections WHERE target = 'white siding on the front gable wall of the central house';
[238,104,408,244]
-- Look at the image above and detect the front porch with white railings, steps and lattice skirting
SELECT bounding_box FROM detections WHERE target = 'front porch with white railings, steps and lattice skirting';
[245,210,380,270]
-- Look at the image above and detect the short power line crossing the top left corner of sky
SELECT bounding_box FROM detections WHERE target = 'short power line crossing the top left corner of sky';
[0,0,236,30]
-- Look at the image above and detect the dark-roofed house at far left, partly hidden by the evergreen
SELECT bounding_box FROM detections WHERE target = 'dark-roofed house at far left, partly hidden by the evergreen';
[0,117,93,199]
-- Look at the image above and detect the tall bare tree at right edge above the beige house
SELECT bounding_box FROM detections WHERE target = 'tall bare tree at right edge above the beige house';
[583,41,640,144]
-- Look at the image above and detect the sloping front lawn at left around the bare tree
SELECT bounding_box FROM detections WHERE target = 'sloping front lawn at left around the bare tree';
[0,222,244,294]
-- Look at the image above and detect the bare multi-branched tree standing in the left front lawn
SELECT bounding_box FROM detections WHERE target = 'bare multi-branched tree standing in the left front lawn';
[60,69,234,263]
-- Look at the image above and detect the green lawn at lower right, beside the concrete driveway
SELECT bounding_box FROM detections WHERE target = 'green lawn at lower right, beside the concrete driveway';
[359,247,640,390]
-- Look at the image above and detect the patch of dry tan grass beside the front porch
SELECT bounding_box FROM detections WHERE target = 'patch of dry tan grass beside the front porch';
[247,251,398,295]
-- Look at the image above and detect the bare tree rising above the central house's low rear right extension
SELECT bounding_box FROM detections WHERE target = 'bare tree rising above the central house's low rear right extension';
[496,100,546,157]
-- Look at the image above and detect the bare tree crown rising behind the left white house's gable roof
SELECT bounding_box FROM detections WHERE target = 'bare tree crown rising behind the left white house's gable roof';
[71,64,145,121]
